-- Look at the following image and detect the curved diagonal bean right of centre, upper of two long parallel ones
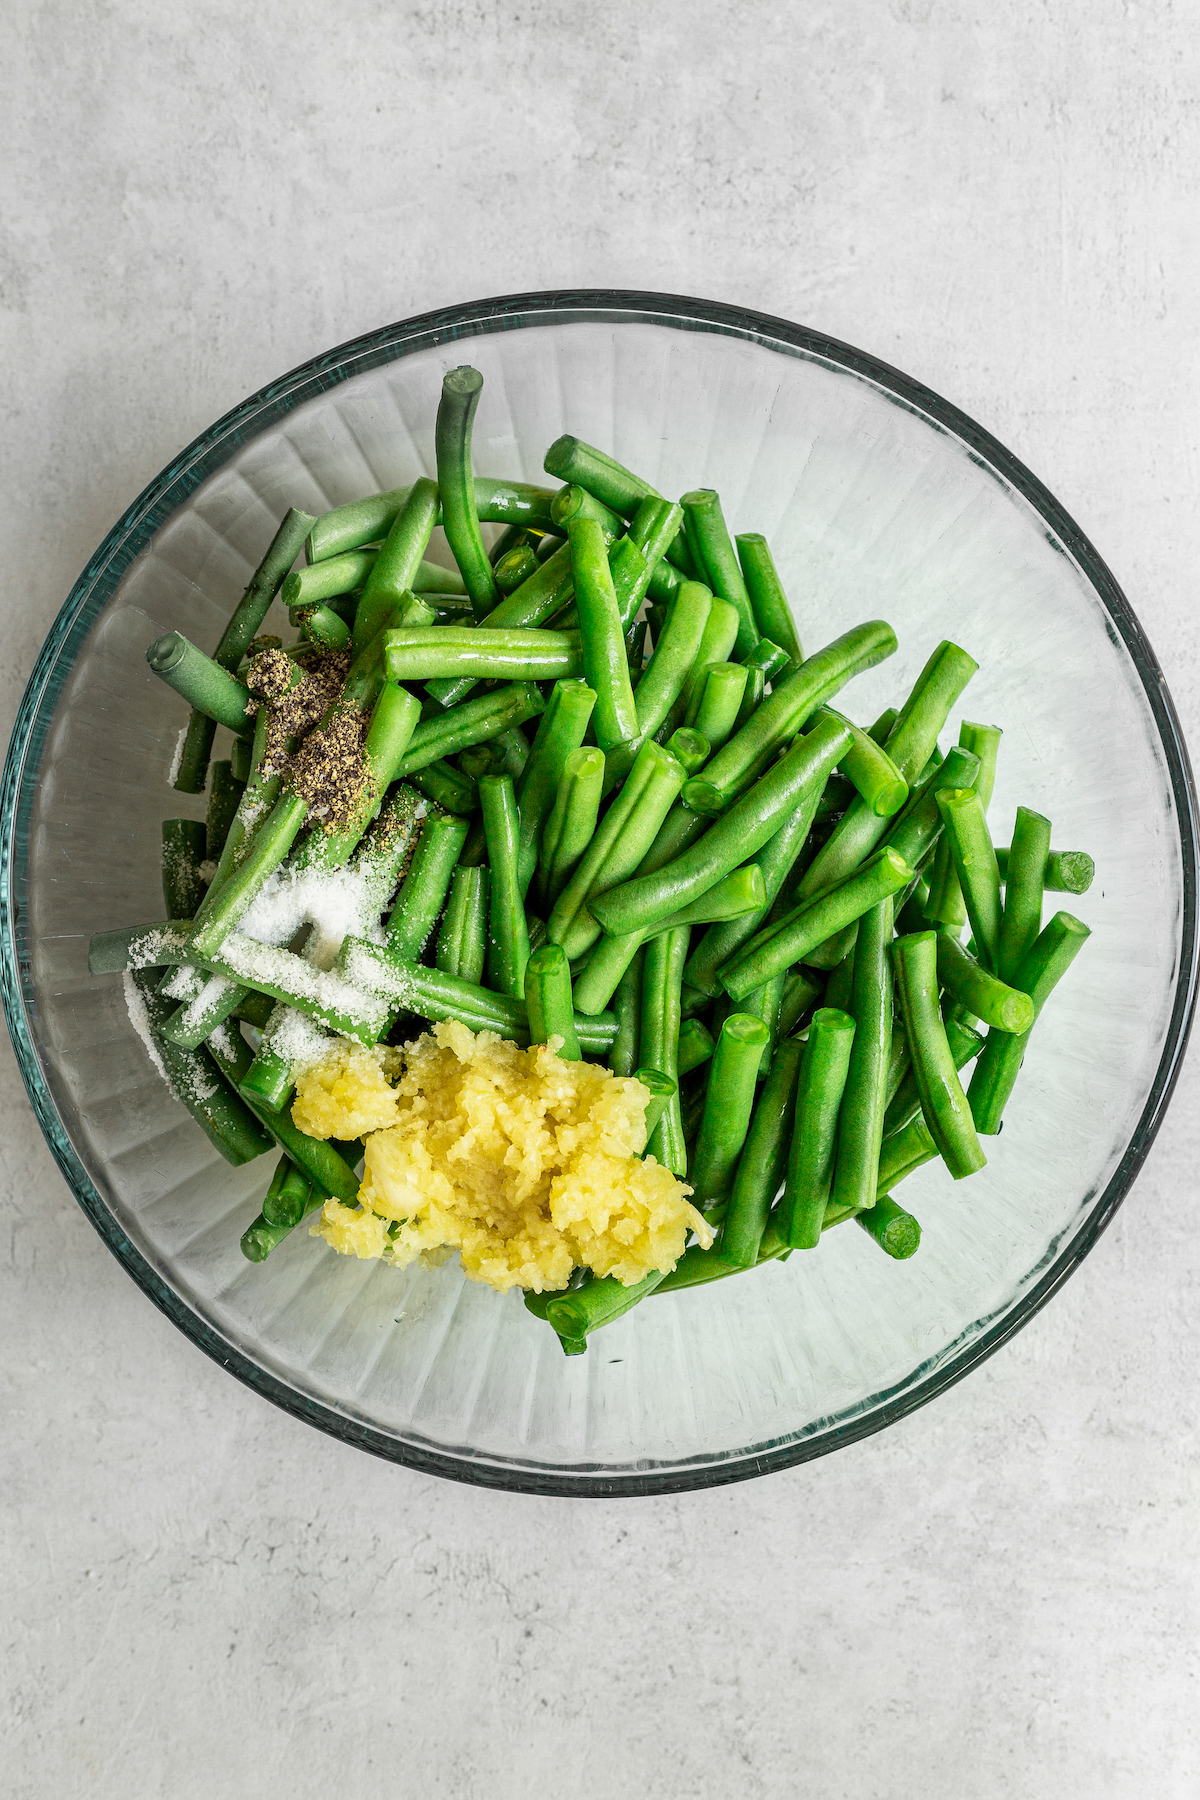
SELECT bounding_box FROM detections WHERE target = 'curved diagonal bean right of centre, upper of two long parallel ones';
[684,619,896,817]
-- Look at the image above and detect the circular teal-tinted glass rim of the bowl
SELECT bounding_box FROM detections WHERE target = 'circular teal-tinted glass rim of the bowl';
[0,288,1200,1498]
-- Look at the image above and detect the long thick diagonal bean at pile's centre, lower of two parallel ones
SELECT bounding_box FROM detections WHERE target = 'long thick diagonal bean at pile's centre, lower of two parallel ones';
[594,720,849,943]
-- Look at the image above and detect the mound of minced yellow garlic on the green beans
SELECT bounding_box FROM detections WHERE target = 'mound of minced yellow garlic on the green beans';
[293,1022,712,1292]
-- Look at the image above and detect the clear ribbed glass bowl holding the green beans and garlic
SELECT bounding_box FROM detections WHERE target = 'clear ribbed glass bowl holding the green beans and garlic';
[0,292,1196,1494]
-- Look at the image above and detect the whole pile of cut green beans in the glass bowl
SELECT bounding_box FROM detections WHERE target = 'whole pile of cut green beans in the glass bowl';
[98,367,1094,1355]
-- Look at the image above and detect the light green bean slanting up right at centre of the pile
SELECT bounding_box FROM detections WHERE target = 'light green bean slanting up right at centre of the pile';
[547,740,683,972]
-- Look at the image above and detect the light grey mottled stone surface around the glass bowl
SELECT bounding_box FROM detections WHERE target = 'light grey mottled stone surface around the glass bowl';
[0,0,1200,1800]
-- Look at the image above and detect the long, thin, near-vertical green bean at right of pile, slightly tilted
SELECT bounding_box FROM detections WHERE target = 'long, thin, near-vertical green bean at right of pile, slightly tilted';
[829,896,892,1211]
